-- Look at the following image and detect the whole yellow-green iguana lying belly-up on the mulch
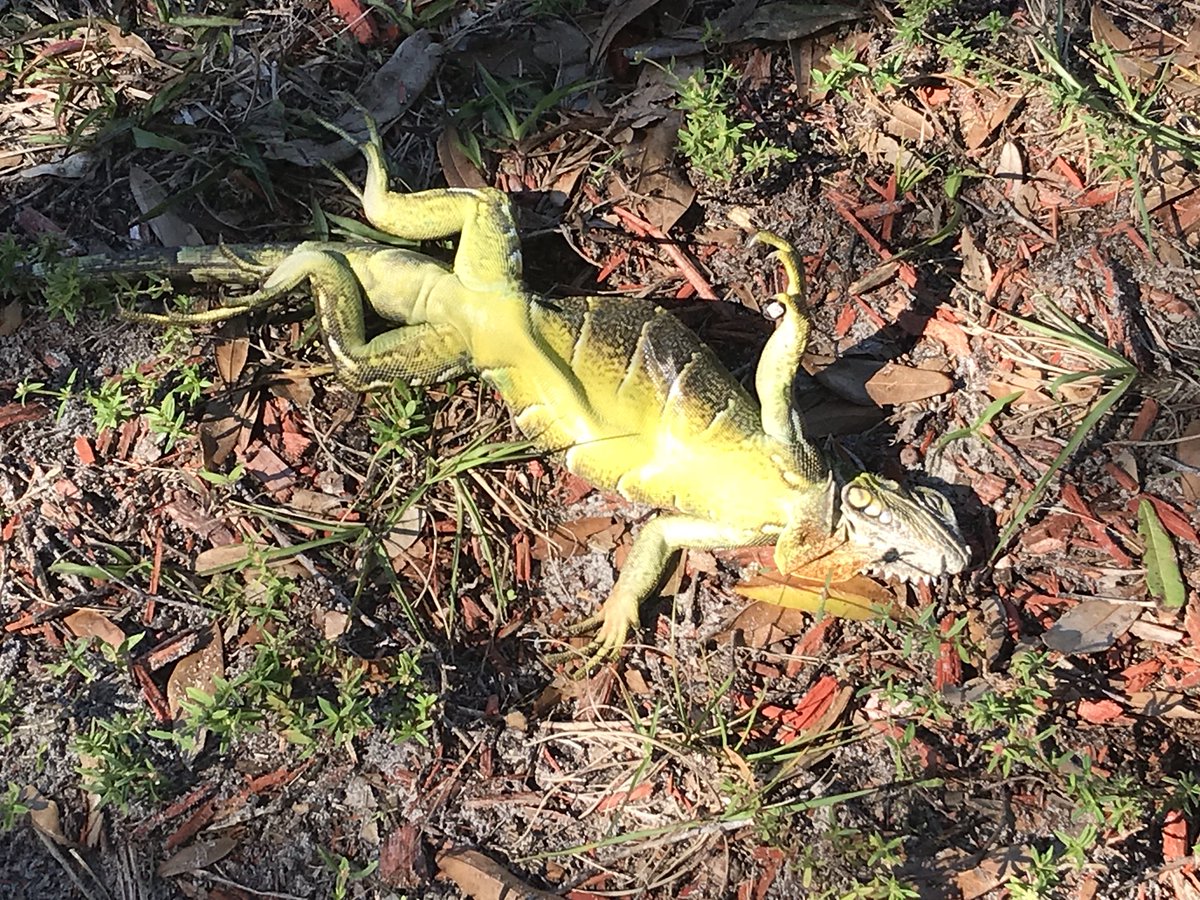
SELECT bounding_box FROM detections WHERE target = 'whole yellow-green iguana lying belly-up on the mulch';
[21,121,968,667]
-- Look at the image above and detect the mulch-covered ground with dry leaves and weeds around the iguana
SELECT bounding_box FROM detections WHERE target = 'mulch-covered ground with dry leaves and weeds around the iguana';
[0,0,1200,900]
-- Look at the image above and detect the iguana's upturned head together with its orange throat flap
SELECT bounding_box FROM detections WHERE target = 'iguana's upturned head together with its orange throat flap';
[775,472,971,582]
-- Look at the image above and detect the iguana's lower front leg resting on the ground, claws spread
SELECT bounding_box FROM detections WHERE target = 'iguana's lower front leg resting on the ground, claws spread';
[545,515,766,672]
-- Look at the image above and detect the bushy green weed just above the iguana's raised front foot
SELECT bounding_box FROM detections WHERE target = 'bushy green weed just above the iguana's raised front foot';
[677,64,796,181]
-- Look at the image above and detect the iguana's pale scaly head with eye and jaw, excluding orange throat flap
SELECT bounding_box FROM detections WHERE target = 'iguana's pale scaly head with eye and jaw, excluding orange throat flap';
[834,473,971,581]
